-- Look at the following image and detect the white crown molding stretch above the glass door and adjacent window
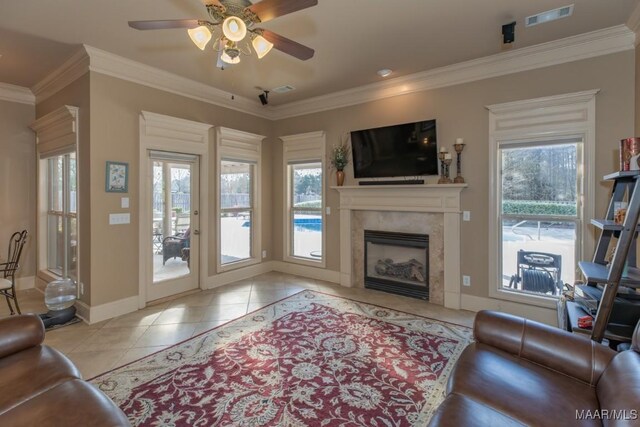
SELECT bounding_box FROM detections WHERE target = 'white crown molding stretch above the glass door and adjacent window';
[84,45,269,118]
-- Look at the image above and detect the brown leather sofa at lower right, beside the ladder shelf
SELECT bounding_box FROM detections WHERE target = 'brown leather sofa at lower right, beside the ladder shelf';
[429,311,640,427]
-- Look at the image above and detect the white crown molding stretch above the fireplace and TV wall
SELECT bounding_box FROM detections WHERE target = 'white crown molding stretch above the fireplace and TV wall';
[271,25,635,119]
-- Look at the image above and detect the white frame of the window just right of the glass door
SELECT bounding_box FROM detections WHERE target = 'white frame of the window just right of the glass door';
[216,127,265,273]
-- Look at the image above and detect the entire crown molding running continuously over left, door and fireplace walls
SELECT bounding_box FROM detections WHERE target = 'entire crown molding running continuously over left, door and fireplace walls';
[26,24,640,120]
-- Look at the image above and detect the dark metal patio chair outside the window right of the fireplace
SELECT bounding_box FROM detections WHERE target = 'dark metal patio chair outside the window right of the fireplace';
[509,250,563,295]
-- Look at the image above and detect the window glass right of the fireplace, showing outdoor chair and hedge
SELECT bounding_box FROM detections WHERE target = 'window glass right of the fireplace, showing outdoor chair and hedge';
[498,138,582,297]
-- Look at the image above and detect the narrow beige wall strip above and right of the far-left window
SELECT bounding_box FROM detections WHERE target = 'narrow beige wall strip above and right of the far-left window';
[36,73,92,304]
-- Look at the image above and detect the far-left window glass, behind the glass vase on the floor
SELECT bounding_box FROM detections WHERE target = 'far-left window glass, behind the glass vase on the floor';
[42,153,78,280]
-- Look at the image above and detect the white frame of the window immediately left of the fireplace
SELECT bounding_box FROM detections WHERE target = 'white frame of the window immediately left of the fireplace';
[280,131,327,268]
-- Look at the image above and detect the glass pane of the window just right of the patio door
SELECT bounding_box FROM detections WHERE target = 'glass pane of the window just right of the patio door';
[220,160,255,265]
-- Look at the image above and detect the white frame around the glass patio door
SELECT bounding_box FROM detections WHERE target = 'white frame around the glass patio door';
[138,111,213,308]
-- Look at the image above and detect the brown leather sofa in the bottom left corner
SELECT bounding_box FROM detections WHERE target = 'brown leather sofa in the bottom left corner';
[0,315,130,427]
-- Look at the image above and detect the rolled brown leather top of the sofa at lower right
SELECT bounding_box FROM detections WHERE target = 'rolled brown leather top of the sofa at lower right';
[473,311,616,385]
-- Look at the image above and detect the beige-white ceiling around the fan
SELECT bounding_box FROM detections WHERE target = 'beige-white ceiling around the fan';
[0,0,640,105]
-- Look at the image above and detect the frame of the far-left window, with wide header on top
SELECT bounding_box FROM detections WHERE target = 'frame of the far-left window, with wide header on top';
[31,105,82,283]
